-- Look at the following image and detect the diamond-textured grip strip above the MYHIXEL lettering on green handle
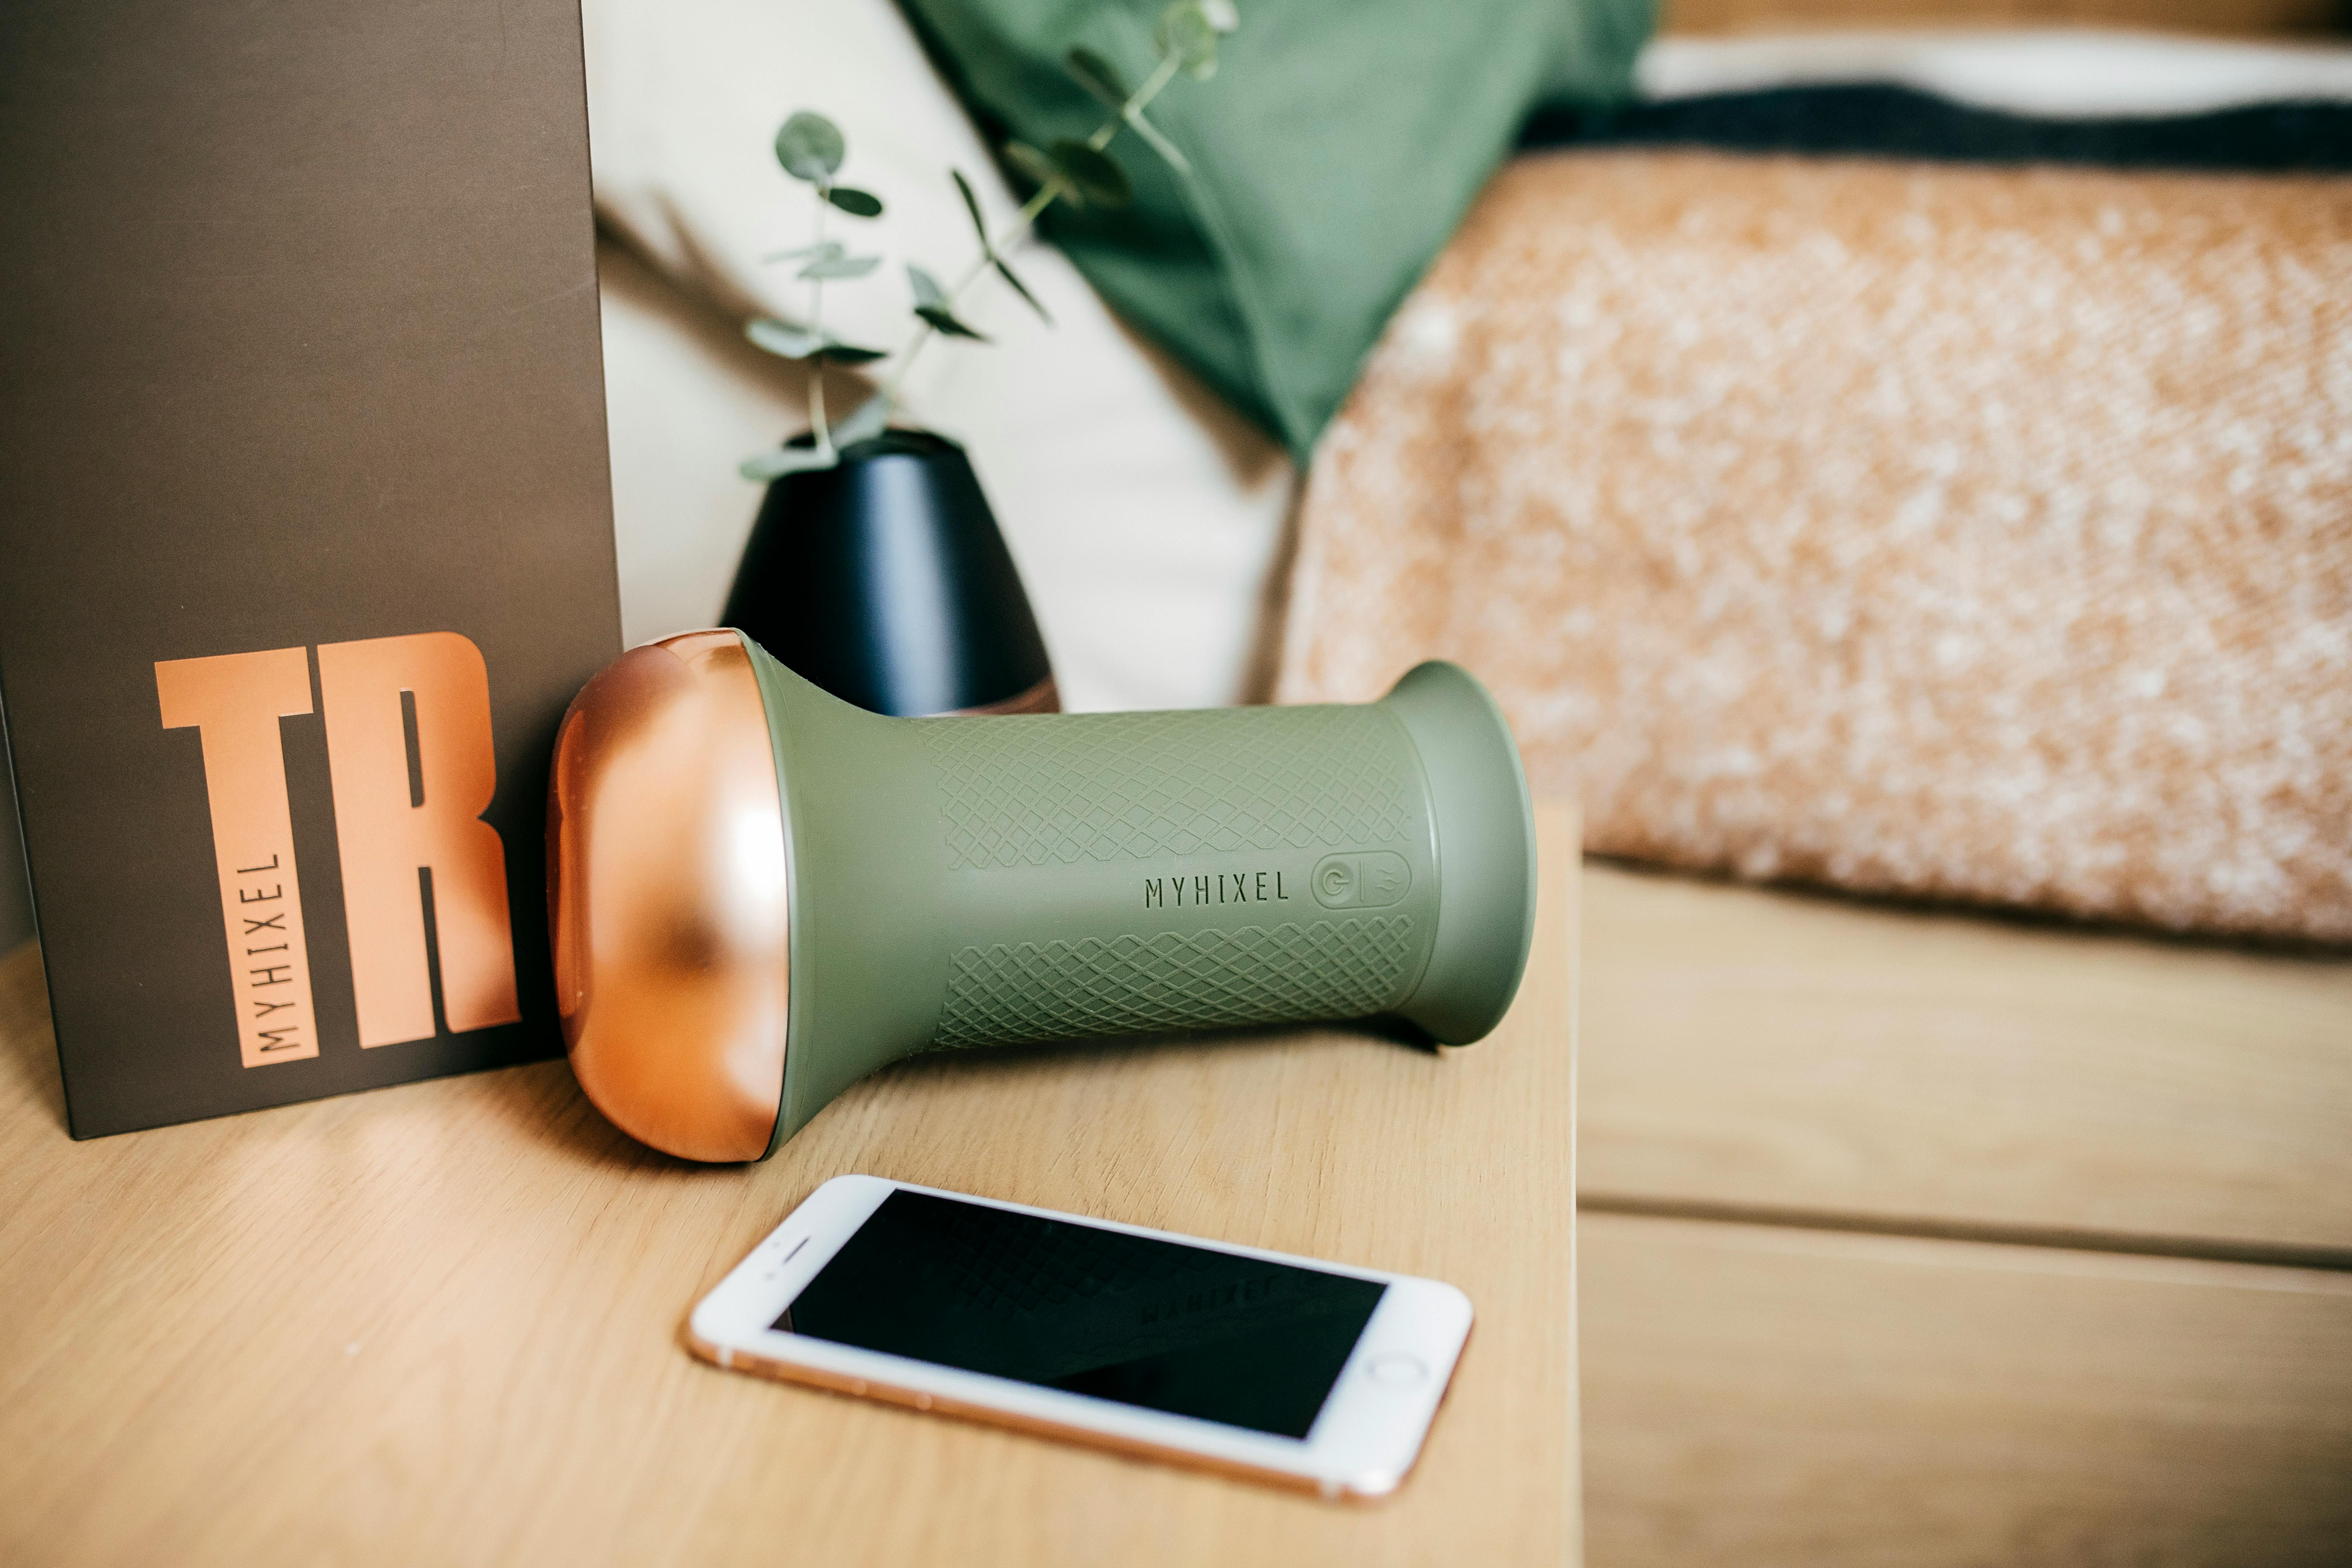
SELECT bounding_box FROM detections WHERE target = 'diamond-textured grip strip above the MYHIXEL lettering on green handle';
[917,708,1421,870]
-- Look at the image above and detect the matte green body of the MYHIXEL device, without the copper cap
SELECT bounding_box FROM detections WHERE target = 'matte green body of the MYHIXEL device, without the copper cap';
[753,646,1533,1142]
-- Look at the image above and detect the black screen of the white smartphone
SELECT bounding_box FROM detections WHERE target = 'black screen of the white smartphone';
[776,1190,1388,1436]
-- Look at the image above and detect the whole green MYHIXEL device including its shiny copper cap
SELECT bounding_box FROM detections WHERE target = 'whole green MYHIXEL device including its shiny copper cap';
[548,630,1536,1161]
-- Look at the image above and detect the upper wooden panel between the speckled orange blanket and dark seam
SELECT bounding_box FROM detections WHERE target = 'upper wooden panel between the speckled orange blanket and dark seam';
[1580,865,2352,1262]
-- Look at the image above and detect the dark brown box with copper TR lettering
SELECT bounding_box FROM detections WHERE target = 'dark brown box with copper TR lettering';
[0,0,621,1138]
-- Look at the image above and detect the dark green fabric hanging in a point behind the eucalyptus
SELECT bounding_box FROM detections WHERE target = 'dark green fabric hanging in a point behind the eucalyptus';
[901,0,1653,466]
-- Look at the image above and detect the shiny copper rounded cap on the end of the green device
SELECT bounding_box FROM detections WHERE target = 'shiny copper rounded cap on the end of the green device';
[548,632,793,1161]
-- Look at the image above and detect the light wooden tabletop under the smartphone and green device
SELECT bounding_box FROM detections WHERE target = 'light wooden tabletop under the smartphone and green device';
[0,809,1580,1568]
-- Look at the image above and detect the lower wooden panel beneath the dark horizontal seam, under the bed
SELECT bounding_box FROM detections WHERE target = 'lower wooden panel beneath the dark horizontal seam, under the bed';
[1580,1213,2352,1568]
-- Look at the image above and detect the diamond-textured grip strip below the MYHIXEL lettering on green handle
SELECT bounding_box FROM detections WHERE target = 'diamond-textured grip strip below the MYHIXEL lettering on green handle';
[931,915,1418,1048]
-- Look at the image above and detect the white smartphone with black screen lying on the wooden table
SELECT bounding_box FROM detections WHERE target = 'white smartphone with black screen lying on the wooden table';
[687,1176,1470,1497]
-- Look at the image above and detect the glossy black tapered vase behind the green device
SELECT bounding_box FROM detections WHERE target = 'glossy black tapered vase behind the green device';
[727,430,1061,715]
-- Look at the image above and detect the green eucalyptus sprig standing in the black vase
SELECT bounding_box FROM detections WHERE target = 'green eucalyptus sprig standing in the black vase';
[741,0,1242,482]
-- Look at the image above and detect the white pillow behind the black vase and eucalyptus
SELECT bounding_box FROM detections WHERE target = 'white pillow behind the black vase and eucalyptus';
[581,0,1294,708]
